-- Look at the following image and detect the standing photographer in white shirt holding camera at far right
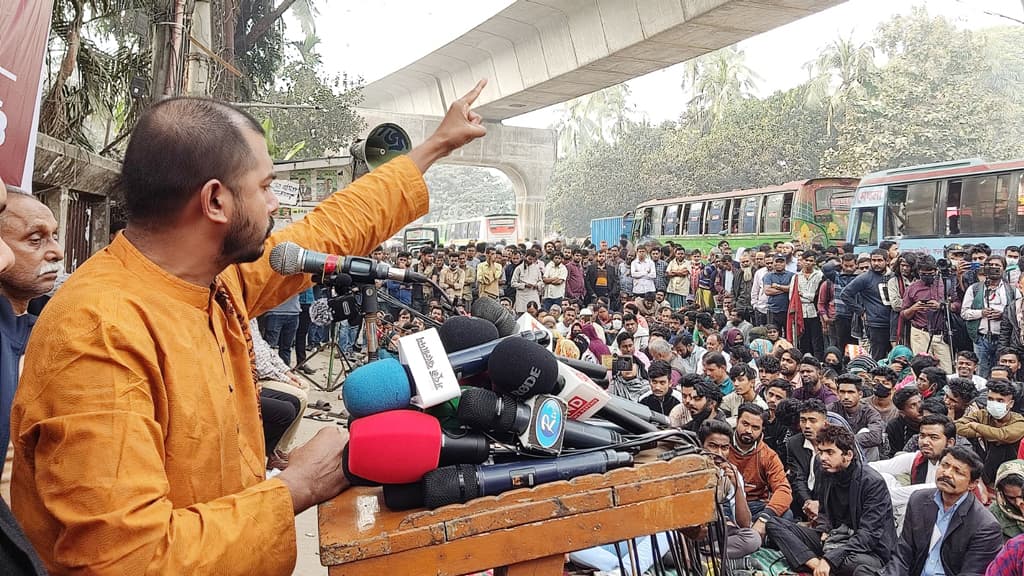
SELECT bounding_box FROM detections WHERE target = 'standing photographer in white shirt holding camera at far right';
[961,256,1018,378]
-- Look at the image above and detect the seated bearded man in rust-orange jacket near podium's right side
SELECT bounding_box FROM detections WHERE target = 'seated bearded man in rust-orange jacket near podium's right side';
[729,403,793,538]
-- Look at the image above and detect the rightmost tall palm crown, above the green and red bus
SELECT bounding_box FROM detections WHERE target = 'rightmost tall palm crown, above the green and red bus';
[804,38,879,134]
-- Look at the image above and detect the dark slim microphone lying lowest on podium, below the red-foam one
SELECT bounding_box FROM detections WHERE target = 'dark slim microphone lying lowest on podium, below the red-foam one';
[417,450,633,509]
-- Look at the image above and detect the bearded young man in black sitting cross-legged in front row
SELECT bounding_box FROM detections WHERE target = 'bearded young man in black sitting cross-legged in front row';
[767,426,892,576]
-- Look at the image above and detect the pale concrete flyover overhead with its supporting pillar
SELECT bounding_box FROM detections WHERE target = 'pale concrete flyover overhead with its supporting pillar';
[361,0,844,239]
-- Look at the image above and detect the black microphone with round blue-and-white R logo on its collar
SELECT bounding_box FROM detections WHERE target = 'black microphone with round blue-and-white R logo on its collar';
[457,388,623,453]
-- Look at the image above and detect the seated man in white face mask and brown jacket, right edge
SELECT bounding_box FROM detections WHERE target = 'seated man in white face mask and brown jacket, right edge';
[956,380,1024,487]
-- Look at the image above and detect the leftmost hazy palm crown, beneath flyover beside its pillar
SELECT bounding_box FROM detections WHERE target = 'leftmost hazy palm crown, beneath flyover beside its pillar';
[554,84,630,155]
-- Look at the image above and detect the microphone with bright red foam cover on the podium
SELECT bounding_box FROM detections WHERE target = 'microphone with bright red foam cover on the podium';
[344,410,490,484]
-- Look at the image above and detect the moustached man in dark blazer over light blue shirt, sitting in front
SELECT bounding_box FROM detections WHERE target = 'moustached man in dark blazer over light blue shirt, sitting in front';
[882,446,1002,576]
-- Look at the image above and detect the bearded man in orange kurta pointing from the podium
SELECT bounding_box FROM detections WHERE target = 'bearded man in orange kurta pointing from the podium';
[11,82,484,576]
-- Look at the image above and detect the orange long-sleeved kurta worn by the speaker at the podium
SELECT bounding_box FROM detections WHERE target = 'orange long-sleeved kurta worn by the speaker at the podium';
[11,158,428,576]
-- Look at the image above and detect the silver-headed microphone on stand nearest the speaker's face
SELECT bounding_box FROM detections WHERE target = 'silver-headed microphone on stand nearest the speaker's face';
[270,242,428,283]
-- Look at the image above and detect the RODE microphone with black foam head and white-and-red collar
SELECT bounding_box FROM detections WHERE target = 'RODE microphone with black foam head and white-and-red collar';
[487,338,669,434]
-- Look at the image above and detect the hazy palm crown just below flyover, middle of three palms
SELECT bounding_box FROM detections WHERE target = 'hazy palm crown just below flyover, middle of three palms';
[682,46,761,132]
